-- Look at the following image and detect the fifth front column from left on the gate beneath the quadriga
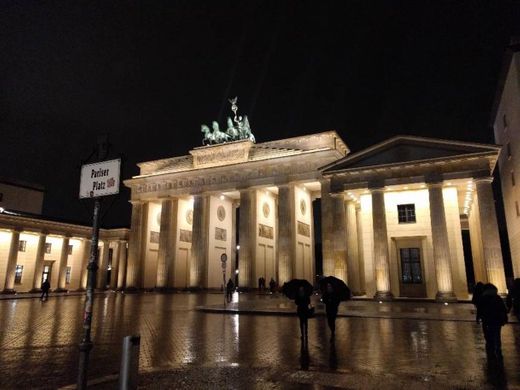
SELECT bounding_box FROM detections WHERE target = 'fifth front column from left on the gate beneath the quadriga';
[277,184,296,285]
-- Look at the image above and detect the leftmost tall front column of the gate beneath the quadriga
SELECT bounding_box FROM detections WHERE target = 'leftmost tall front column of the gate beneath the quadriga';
[126,201,148,290]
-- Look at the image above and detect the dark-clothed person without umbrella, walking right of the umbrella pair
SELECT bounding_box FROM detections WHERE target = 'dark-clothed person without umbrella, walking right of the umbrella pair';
[478,283,507,360]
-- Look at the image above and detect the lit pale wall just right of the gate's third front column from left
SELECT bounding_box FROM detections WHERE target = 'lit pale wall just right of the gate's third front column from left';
[207,196,235,288]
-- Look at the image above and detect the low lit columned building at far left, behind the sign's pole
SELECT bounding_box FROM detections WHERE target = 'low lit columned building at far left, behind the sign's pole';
[0,210,129,293]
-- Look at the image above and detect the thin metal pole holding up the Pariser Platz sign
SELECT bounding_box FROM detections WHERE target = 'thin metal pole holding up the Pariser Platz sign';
[78,198,101,390]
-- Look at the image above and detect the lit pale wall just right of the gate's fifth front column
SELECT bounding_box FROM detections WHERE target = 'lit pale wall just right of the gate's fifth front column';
[294,186,315,283]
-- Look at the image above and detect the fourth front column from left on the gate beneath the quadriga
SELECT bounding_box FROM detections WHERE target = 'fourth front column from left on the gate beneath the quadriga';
[238,189,256,288]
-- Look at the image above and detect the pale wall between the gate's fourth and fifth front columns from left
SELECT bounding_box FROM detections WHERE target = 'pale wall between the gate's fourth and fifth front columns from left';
[255,190,278,286]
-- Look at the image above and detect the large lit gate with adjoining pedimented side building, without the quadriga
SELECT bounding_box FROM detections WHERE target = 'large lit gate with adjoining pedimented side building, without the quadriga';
[125,131,506,301]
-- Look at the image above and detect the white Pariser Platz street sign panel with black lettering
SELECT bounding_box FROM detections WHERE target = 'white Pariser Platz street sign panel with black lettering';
[79,159,121,199]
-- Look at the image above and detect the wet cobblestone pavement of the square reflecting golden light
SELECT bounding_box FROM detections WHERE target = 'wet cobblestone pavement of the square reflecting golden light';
[0,293,520,389]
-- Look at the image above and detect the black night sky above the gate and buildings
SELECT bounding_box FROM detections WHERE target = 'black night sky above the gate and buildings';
[0,0,520,226]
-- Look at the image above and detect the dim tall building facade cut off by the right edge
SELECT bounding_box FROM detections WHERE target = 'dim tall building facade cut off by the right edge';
[493,44,520,278]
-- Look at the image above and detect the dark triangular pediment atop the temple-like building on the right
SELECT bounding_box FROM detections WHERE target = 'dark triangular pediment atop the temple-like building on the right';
[322,136,500,174]
